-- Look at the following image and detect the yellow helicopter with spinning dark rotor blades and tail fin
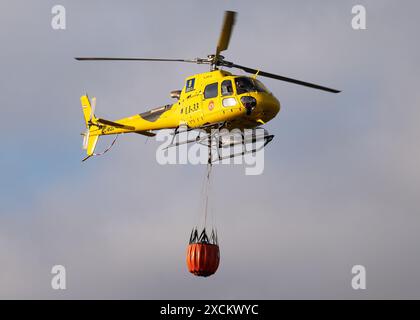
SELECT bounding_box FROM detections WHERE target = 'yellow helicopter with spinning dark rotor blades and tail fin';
[75,11,340,161]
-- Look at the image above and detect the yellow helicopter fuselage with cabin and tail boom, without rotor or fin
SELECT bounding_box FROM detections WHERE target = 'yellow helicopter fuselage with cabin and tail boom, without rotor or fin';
[91,70,280,135]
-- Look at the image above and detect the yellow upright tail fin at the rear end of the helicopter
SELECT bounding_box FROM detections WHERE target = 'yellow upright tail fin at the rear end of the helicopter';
[80,95,99,161]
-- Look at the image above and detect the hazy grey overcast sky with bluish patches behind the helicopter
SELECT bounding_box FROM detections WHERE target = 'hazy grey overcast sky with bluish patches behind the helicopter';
[0,0,420,299]
